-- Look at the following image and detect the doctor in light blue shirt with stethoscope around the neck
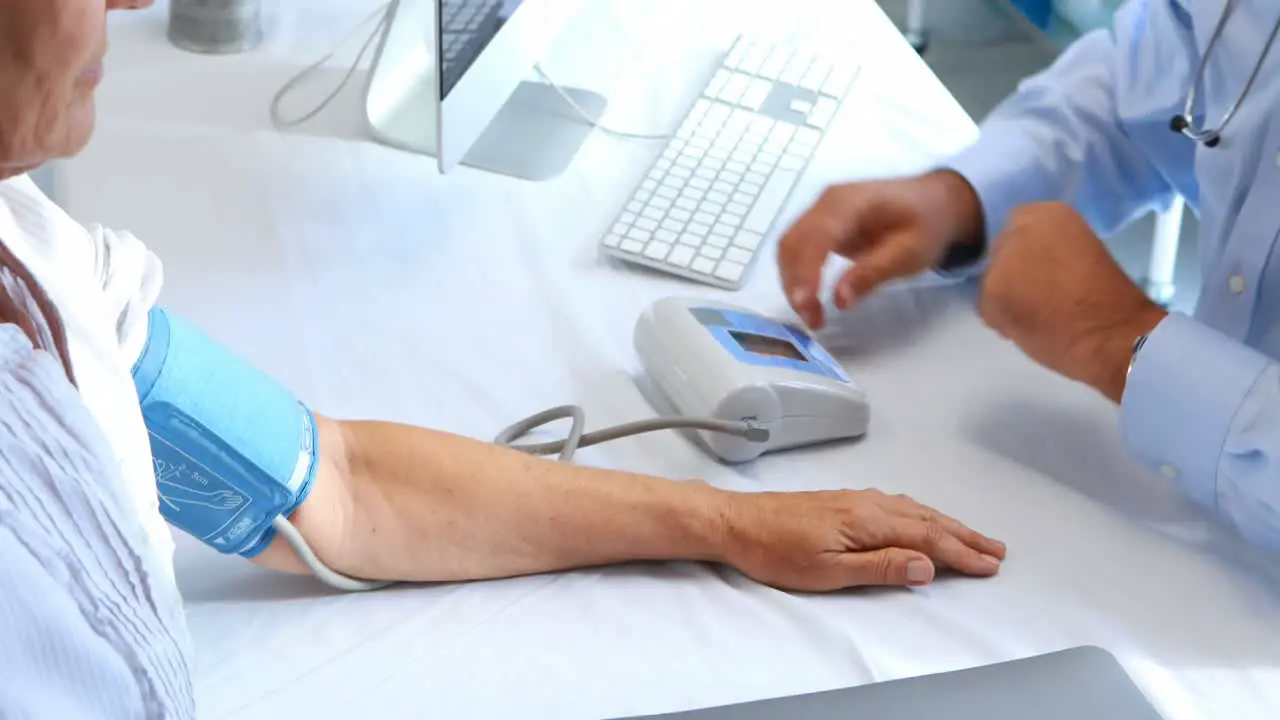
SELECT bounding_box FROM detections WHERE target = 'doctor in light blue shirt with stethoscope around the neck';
[780,0,1280,551]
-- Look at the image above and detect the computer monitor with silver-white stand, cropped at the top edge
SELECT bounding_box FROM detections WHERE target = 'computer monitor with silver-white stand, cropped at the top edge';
[365,0,605,181]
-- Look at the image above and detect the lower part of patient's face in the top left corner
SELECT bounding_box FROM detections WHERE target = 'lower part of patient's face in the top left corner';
[0,0,154,178]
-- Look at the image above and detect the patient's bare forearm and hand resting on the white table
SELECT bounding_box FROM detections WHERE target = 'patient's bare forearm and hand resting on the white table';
[257,418,1005,591]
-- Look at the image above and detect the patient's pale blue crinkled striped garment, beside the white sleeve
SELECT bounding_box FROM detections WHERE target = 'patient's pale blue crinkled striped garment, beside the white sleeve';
[0,325,195,720]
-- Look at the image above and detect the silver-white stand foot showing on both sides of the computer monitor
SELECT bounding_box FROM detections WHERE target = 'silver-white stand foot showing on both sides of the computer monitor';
[365,3,608,181]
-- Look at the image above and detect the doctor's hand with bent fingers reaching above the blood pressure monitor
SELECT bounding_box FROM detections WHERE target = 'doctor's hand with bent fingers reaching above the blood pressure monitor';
[778,170,984,329]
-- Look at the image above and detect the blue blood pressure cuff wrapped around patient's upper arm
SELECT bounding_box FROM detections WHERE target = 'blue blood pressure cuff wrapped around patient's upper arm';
[133,307,319,557]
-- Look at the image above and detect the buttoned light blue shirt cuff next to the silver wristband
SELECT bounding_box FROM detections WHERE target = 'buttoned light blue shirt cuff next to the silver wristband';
[1120,313,1270,509]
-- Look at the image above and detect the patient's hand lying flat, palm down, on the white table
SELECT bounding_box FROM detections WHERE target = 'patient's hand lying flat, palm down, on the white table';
[723,489,1005,592]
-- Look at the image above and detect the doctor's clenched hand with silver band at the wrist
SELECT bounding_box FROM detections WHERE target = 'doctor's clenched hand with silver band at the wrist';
[978,202,1166,402]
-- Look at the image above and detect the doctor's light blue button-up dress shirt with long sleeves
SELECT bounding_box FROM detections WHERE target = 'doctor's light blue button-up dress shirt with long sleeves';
[948,0,1280,551]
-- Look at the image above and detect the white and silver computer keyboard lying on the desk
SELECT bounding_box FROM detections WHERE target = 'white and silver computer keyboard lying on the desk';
[600,37,858,290]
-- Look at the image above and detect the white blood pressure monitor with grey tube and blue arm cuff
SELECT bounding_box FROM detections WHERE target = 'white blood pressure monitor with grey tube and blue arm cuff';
[133,299,868,591]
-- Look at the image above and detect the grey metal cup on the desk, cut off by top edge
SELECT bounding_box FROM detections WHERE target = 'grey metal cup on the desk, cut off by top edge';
[169,0,265,55]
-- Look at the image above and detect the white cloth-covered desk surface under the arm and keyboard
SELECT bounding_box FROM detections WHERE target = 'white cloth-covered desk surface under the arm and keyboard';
[59,0,1280,720]
